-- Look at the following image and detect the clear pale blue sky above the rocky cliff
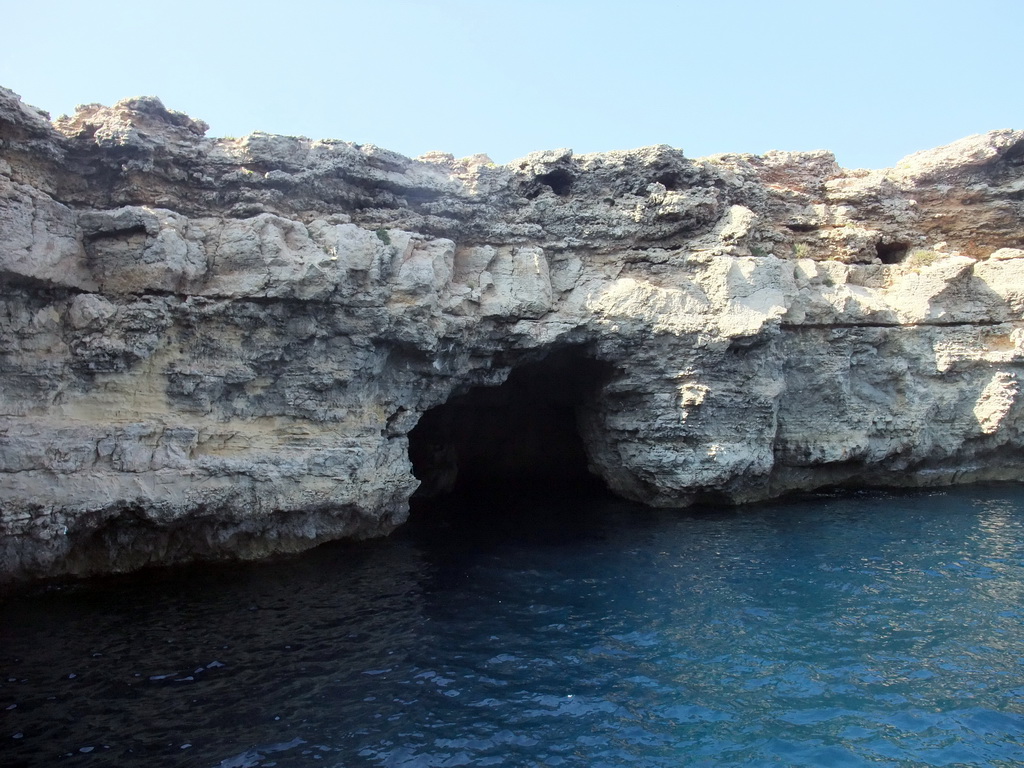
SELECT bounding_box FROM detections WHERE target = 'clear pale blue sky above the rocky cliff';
[0,0,1024,168]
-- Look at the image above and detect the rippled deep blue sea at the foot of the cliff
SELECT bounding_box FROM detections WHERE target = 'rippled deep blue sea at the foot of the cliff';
[0,486,1024,768]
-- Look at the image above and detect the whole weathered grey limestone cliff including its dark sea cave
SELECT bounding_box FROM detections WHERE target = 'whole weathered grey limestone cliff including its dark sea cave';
[0,89,1024,580]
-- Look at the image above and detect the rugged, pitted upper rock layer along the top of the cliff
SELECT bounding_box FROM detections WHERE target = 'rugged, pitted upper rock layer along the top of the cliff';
[0,88,1024,262]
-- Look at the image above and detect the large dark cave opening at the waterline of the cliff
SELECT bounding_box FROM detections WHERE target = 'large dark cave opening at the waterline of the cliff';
[409,348,611,502]
